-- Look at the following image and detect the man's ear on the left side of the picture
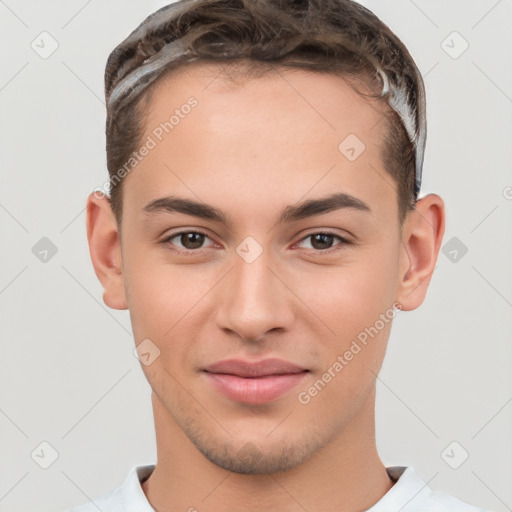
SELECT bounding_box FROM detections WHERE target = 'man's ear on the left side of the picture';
[86,191,128,309]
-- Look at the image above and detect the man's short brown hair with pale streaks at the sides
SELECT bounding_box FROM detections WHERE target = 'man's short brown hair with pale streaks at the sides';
[105,0,426,224]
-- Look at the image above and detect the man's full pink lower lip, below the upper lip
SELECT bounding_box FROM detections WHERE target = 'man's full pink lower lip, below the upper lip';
[205,371,309,404]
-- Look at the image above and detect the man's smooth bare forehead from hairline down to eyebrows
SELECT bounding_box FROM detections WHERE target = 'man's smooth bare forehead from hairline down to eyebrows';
[121,62,396,223]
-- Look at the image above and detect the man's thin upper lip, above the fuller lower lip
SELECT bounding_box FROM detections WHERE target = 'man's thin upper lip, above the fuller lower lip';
[204,358,307,377]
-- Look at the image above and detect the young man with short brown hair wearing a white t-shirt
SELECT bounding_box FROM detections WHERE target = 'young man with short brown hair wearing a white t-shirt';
[70,0,486,512]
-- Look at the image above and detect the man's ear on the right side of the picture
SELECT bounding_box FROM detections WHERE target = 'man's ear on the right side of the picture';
[396,194,445,311]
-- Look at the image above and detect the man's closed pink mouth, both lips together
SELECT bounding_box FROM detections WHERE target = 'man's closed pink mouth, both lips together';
[202,359,310,405]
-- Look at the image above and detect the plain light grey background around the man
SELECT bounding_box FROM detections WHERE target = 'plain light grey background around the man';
[0,0,512,512]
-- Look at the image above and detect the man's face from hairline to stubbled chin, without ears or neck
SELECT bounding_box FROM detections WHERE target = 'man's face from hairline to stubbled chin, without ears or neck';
[116,64,401,473]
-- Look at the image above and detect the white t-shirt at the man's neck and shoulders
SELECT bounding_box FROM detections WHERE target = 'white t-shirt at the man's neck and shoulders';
[69,464,486,512]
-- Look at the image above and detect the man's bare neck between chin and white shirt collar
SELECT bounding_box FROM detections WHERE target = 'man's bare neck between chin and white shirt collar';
[142,388,394,512]
